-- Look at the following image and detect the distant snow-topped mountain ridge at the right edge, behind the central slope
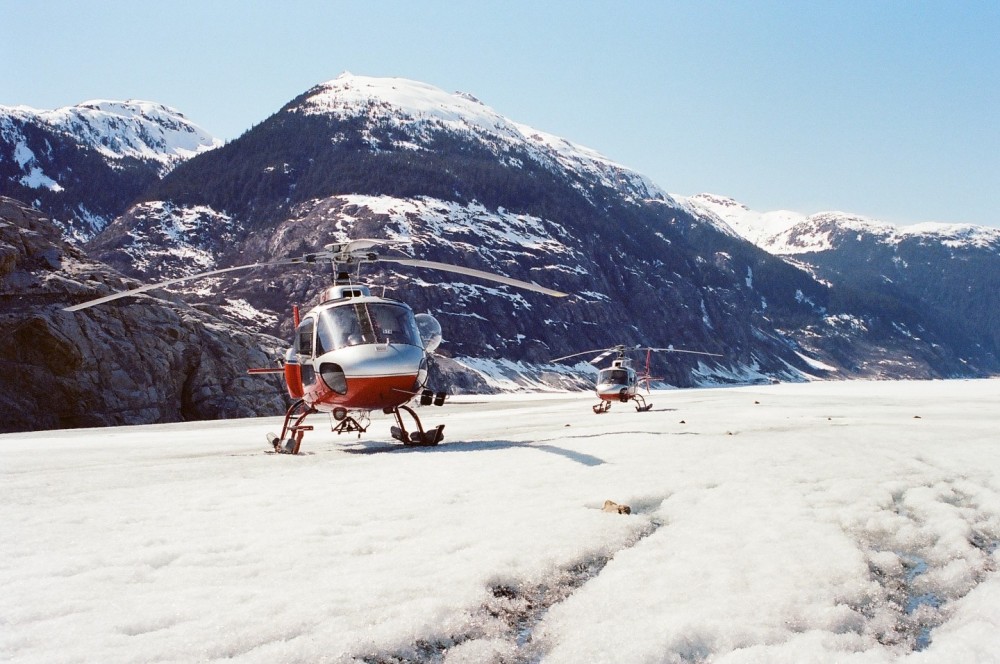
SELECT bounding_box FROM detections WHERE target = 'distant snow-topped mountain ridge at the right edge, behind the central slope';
[685,195,1000,371]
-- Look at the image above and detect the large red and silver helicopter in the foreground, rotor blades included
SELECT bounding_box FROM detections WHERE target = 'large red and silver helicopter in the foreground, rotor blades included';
[65,239,567,454]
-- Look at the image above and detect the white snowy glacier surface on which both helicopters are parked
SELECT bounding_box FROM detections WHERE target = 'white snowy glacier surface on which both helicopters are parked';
[0,381,1000,663]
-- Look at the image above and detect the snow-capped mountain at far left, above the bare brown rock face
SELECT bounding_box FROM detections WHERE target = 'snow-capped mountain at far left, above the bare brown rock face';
[0,100,221,240]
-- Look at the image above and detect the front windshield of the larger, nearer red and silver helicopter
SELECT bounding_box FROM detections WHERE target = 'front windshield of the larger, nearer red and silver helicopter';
[316,302,423,355]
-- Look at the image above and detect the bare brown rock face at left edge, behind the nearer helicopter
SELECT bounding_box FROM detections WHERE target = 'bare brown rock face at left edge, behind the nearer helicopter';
[0,198,286,432]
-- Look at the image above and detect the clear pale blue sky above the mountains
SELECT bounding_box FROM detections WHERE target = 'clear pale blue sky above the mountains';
[0,0,1000,226]
